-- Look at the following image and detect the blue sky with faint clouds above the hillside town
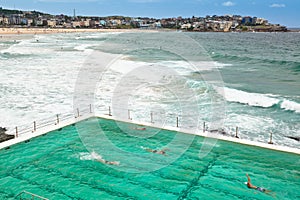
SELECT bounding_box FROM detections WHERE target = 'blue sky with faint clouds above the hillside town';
[0,0,300,28]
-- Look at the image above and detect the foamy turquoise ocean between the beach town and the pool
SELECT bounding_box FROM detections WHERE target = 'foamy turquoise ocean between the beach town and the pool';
[0,32,300,148]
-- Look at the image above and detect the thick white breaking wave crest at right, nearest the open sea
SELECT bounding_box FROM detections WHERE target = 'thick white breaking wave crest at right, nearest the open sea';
[216,87,280,108]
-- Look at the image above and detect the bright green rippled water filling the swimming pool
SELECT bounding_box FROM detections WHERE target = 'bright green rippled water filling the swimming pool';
[0,118,300,200]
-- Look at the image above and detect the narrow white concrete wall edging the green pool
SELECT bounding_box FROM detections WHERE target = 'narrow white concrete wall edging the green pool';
[0,114,300,155]
